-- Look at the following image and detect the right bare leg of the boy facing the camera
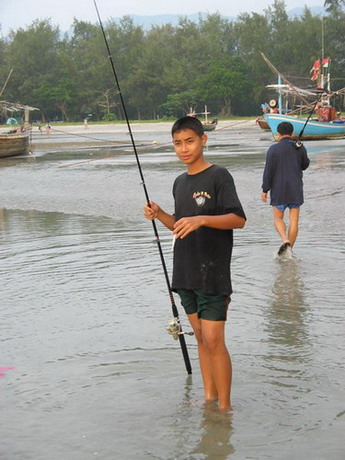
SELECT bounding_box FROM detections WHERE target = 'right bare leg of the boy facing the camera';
[201,319,232,409]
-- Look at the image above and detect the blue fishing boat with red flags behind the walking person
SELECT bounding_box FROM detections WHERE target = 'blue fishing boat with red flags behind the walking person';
[261,53,345,139]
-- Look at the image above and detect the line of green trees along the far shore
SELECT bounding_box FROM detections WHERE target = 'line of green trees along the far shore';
[0,0,345,121]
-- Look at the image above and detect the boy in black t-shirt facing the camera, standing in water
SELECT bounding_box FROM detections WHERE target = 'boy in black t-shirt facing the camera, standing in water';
[144,116,246,409]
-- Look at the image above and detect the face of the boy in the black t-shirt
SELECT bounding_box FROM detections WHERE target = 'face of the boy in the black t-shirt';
[173,129,207,166]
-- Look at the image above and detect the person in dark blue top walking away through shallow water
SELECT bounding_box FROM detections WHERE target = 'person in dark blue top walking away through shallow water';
[261,122,310,255]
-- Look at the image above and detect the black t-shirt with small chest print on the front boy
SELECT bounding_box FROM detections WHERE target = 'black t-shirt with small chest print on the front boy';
[172,165,245,295]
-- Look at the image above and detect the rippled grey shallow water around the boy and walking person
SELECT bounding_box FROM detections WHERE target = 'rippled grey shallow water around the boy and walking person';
[0,126,345,460]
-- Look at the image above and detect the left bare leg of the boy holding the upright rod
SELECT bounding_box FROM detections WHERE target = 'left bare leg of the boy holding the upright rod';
[188,313,218,401]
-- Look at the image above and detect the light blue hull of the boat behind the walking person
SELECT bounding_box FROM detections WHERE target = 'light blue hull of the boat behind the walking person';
[264,113,345,139]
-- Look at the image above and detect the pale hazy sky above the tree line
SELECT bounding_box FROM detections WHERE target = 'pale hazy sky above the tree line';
[0,0,323,35]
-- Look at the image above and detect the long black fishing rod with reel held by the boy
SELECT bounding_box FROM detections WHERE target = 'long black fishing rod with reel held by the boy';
[93,0,193,374]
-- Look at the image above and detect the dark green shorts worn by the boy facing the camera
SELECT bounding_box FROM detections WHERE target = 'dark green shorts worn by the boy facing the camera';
[176,289,230,321]
